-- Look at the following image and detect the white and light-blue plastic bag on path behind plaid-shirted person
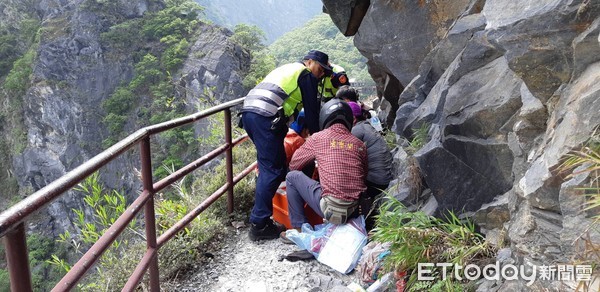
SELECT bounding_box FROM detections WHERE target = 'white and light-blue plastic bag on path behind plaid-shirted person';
[286,215,367,274]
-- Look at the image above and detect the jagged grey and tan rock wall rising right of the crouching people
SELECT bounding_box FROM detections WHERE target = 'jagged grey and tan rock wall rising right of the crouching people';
[323,0,600,289]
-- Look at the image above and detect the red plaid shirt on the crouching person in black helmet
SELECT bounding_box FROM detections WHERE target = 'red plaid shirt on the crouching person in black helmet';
[290,123,369,201]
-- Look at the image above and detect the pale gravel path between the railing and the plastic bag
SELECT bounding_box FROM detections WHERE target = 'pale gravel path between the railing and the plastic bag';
[162,227,359,292]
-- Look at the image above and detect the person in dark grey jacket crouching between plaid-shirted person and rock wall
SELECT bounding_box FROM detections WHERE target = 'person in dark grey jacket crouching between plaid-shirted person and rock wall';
[348,102,393,230]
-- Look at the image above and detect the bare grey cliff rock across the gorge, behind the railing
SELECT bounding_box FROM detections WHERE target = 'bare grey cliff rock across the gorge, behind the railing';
[0,0,249,233]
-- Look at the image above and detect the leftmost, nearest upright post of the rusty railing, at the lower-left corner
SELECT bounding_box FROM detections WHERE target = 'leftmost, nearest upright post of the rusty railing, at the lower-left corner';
[4,223,33,292]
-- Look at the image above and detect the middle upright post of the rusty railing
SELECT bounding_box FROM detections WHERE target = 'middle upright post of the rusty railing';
[140,136,160,292]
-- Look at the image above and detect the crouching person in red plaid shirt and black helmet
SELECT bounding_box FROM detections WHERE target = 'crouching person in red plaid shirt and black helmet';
[280,99,368,242]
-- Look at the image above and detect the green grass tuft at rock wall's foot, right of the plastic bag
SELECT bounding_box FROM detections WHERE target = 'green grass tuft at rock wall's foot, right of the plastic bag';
[373,196,495,289]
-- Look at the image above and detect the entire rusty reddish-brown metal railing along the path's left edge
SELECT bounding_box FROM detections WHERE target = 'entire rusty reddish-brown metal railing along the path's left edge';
[0,98,256,292]
